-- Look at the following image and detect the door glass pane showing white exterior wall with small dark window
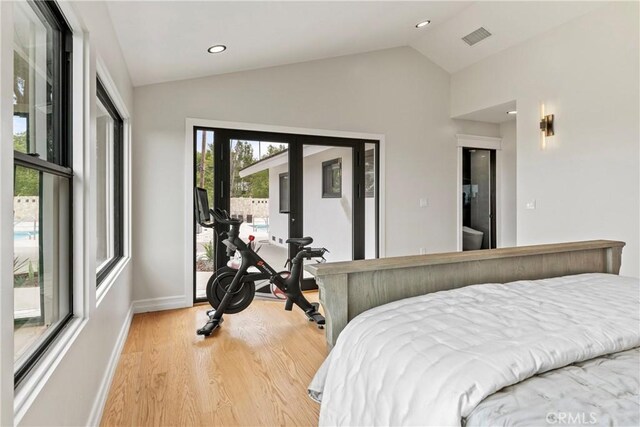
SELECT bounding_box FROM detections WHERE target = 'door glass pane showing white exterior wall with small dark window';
[302,145,353,264]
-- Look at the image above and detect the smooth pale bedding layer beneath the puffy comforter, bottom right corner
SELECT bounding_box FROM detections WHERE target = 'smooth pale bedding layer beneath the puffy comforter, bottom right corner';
[464,347,640,427]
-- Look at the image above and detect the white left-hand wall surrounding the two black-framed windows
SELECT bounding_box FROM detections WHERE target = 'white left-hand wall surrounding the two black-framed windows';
[0,2,133,426]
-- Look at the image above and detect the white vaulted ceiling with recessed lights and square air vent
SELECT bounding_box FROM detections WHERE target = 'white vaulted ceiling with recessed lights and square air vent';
[107,1,601,86]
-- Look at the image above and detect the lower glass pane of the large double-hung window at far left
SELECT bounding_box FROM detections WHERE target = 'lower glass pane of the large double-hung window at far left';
[13,166,71,369]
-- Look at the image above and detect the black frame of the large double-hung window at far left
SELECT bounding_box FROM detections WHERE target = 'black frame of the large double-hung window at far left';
[13,0,74,388]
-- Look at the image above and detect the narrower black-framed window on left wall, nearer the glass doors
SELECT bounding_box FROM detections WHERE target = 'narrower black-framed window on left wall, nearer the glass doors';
[95,79,124,286]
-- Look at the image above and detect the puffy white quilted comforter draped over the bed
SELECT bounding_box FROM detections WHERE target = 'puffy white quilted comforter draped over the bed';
[309,274,640,426]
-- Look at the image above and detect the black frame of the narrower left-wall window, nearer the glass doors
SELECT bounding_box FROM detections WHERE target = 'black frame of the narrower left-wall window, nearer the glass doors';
[96,76,124,287]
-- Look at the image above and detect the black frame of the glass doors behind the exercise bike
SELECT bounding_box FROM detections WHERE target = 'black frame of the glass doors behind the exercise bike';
[192,126,380,302]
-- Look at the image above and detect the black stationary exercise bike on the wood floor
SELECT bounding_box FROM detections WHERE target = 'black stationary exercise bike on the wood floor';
[195,187,327,336]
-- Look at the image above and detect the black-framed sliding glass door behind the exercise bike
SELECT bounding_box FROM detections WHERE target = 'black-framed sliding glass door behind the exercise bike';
[194,129,378,301]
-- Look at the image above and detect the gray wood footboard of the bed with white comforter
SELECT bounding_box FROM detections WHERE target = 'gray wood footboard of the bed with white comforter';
[306,240,625,348]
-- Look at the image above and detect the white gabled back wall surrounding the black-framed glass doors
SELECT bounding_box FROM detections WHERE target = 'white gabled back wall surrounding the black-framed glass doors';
[133,48,464,299]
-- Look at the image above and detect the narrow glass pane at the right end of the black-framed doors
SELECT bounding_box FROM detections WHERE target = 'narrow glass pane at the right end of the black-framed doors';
[364,144,378,259]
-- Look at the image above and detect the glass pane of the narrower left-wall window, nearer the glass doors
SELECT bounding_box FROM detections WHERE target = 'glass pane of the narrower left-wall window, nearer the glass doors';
[96,100,115,271]
